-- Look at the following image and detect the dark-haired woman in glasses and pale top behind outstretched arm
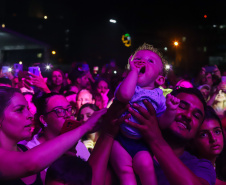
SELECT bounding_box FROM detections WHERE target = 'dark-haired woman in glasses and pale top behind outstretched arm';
[27,93,90,160]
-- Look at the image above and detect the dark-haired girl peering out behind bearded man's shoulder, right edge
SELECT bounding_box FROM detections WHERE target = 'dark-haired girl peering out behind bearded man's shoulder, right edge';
[191,106,226,185]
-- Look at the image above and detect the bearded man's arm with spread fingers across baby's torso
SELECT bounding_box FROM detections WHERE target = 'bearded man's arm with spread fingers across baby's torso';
[125,101,213,185]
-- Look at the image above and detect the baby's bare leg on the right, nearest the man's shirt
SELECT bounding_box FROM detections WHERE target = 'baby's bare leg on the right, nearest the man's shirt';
[133,151,158,185]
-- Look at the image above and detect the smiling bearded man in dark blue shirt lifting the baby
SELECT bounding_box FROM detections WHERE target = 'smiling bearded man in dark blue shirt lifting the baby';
[126,88,216,185]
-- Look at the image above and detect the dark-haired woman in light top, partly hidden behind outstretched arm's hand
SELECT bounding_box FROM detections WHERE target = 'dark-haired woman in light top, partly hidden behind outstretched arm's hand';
[77,103,100,152]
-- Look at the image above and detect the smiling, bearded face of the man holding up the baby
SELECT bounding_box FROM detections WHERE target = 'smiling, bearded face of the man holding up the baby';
[169,93,204,140]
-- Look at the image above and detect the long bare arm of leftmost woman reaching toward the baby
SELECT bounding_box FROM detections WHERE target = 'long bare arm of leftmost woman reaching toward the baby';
[0,109,107,179]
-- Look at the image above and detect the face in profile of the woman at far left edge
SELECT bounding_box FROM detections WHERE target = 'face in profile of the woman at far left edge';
[0,93,34,143]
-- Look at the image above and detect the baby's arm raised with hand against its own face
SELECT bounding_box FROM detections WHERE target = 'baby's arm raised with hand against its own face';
[115,55,140,103]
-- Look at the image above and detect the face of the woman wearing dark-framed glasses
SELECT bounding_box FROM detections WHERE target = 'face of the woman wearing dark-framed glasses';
[44,95,74,135]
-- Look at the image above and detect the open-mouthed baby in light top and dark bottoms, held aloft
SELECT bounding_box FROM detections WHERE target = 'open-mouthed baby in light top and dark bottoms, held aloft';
[111,44,180,185]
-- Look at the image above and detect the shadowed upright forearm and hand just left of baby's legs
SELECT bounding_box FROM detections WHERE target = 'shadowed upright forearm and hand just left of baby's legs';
[88,101,129,185]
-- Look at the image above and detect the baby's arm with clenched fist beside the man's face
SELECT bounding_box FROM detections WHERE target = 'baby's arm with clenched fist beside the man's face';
[158,94,180,129]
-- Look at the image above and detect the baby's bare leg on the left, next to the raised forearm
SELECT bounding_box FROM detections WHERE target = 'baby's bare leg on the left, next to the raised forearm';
[110,141,137,185]
